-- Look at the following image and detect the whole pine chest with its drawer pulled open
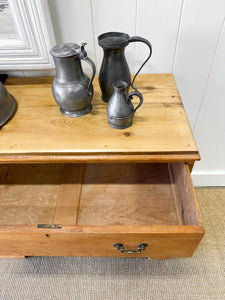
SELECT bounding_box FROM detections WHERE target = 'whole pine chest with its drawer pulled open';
[0,74,204,259]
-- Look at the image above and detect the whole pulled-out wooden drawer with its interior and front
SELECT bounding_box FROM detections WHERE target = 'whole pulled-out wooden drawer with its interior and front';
[0,163,204,259]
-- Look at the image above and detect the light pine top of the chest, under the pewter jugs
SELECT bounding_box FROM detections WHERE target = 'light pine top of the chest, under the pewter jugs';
[0,74,200,163]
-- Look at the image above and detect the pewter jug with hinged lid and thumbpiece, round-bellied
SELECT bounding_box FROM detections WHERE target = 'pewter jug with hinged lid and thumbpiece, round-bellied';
[50,43,96,117]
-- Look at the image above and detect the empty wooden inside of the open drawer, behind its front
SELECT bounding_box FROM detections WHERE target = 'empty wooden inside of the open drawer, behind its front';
[0,163,199,225]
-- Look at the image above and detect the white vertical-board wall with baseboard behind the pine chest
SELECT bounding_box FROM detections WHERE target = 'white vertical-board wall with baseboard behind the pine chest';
[1,0,225,186]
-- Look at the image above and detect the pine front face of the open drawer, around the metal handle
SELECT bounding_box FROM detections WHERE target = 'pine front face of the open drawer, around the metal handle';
[0,225,204,259]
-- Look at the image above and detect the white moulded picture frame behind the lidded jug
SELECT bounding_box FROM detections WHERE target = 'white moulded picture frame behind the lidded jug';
[0,0,55,71]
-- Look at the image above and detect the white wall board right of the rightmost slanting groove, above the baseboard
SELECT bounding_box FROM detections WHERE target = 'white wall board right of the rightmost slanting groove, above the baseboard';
[195,22,225,170]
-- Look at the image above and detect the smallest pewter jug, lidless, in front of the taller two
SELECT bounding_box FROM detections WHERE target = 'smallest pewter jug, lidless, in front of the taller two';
[107,80,143,129]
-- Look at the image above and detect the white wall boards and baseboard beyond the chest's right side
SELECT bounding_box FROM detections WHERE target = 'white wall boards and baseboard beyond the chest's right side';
[172,0,225,186]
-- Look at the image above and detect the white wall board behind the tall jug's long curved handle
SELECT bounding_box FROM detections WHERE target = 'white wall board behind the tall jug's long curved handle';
[135,0,183,73]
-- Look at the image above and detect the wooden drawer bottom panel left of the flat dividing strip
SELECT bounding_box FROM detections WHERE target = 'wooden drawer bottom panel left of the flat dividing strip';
[0,164,63,225]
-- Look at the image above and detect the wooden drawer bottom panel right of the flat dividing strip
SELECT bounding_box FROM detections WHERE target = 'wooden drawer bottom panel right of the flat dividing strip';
[78,164,183,225]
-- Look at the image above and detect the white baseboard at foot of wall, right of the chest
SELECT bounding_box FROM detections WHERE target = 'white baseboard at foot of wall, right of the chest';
[191,171,225,187]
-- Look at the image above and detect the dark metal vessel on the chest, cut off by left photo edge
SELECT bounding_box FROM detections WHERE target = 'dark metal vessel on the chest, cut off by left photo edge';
[0,82,16,126]
